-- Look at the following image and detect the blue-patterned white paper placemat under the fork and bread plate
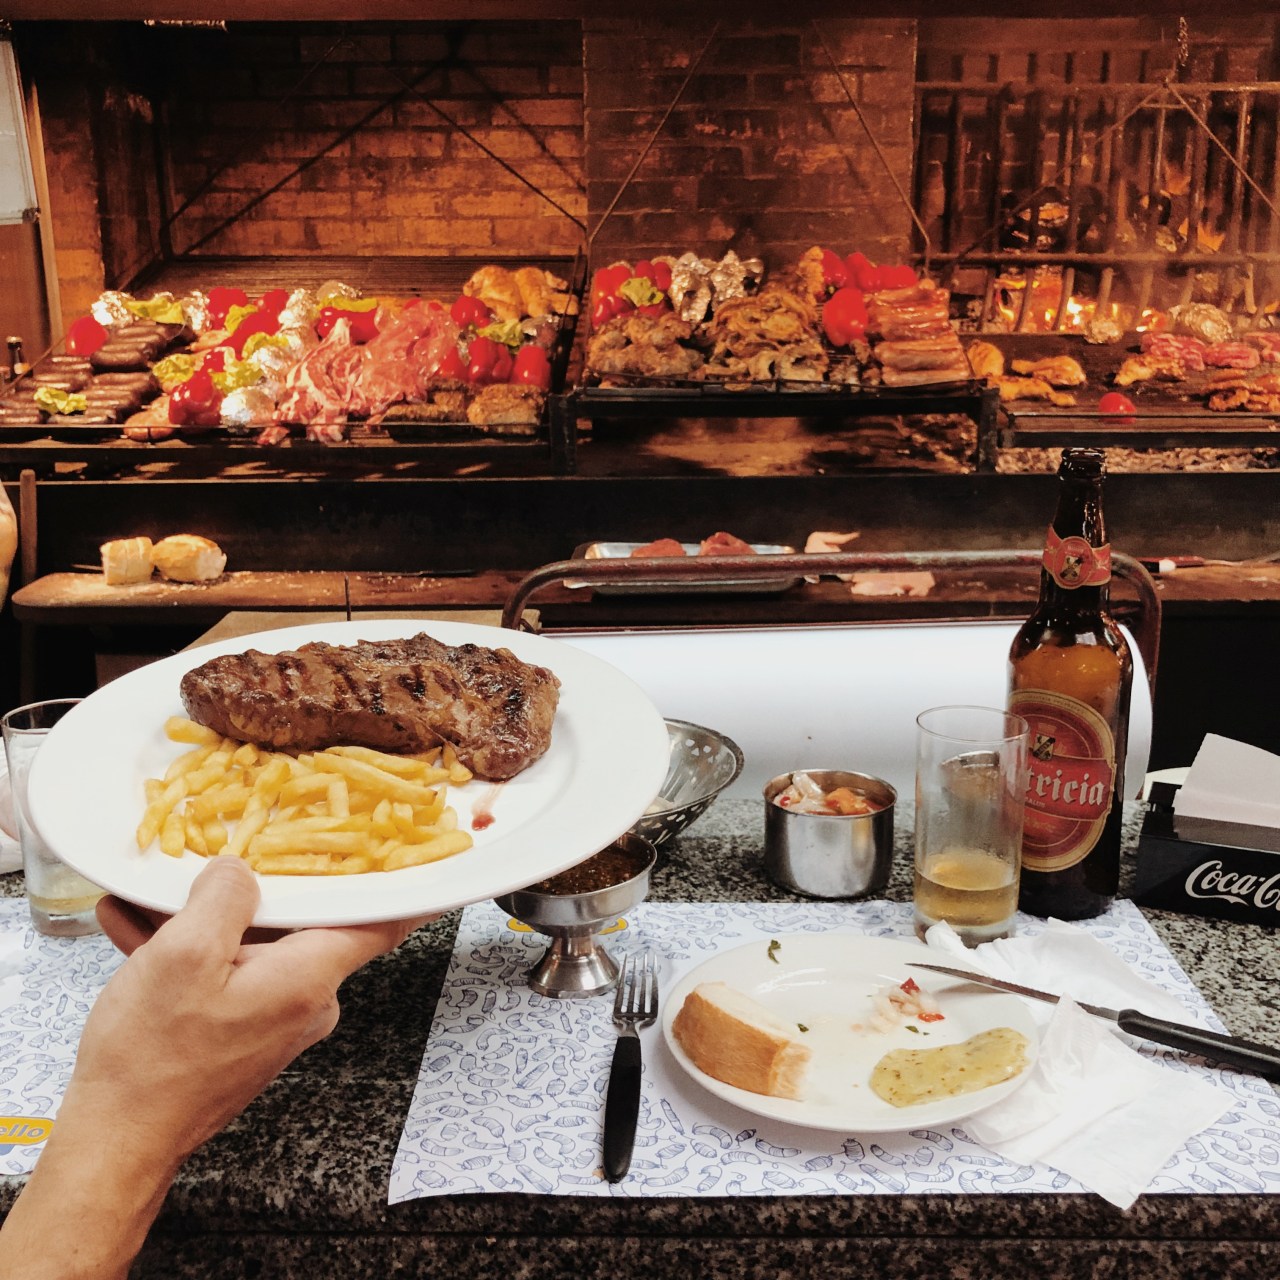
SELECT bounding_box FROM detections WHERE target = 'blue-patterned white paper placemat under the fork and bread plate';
[388,901,1280,1204]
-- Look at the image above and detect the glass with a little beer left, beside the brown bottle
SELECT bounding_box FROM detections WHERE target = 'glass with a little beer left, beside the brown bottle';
[913,707,1028,947]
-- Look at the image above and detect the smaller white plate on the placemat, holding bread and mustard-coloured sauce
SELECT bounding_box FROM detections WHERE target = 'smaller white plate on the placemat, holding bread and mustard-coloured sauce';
[662,933,1039,1134]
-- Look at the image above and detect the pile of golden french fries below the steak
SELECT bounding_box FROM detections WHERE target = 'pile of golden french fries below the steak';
[137,716,472,876]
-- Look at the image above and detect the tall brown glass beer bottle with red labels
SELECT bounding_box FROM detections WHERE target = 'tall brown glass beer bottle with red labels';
[1009,449,1133,920]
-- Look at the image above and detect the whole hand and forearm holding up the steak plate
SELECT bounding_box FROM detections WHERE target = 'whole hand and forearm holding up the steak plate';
[0,856,435,1280]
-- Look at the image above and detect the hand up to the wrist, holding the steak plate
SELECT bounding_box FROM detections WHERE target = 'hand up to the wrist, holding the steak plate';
[70,858,433,1170]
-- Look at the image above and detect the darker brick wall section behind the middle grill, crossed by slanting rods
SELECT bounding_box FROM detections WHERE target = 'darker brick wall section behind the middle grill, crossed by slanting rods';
[584,20,915,272]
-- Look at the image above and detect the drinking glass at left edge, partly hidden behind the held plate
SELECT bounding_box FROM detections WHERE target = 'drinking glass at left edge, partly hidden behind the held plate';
[0,698,102,937]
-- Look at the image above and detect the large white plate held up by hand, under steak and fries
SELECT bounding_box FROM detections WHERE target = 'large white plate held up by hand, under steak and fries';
[31,620,669,928]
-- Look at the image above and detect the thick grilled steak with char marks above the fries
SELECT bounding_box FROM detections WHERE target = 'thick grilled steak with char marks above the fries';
[182,635,559,781]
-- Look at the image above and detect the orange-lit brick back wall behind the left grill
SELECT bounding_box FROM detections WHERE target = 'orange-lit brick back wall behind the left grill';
[160,22,584,256]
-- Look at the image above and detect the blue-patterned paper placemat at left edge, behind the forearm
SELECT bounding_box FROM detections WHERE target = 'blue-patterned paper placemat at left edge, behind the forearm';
[0,897,124,1174]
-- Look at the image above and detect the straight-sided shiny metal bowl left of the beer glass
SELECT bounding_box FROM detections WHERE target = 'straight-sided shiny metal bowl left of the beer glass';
[764,769,897,897]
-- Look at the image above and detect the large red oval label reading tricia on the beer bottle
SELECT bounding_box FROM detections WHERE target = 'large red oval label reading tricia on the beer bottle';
[1009,689,1116,872]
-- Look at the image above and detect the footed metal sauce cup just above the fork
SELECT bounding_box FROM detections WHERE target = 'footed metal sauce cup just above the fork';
[494,832,657,1000]
